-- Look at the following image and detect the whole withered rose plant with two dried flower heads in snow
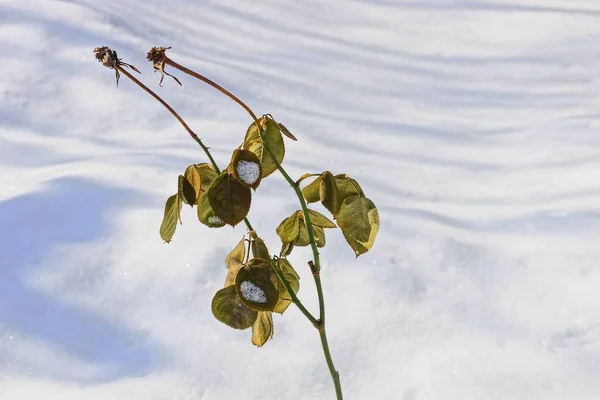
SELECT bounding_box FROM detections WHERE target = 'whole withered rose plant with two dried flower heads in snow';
[94,46,379,399]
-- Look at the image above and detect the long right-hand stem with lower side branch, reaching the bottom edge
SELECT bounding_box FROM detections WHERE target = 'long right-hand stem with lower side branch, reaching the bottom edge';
[163,55,343,400]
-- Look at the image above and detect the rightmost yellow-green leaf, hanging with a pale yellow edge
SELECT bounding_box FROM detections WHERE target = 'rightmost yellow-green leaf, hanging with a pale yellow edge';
[337,195,379,257]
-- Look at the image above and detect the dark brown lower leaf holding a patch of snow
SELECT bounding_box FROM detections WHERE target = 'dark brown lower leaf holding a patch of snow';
[235,258,279,311]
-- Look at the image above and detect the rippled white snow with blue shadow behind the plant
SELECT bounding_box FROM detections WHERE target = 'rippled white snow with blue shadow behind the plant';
[0,0,600,400]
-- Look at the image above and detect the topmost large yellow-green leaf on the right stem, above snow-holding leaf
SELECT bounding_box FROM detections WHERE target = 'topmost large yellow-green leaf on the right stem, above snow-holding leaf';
[243,116,285,178]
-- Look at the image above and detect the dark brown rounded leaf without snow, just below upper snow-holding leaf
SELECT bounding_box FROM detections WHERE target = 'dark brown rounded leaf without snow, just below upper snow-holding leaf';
[207,171,252,226]
